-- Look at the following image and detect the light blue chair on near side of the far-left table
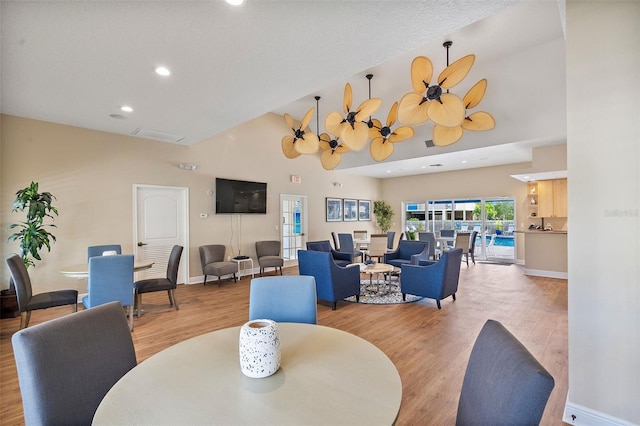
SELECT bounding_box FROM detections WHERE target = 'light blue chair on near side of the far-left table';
[82,254,134,331]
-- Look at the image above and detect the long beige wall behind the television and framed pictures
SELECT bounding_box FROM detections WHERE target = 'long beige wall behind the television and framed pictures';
[0,114,381,292]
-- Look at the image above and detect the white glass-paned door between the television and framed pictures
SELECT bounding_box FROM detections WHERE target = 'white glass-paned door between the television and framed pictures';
[280,194,307,260]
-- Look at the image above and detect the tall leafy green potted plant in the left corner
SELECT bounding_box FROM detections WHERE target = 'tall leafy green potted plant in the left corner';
[2,182,58,317]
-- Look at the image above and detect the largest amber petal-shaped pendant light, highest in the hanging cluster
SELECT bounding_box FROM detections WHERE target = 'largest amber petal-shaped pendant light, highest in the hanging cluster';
[398,41,475,127]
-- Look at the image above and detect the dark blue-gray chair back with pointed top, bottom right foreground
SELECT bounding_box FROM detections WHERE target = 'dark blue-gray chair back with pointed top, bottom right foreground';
[456,320,555,425]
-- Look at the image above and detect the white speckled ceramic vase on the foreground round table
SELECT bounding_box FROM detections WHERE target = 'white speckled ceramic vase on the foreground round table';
[240,319,280,378]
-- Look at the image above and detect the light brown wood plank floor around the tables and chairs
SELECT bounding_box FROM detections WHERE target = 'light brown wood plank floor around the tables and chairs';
[0,263,568,425]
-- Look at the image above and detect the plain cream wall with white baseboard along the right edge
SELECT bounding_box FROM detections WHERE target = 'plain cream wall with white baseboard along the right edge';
[566,0,640,424]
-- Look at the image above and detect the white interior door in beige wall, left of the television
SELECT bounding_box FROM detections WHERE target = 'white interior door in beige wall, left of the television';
[133,185,189,284]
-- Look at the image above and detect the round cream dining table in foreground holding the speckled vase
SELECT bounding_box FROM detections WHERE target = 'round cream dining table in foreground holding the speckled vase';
[93,323,402,425]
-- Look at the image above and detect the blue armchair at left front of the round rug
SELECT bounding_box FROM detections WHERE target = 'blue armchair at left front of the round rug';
[298,250,360,310]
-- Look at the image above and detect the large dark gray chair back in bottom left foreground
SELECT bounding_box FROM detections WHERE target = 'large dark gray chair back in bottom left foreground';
[11,302,137,425]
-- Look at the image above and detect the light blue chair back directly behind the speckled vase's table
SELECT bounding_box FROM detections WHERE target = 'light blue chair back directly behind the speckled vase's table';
[249,275,317,324]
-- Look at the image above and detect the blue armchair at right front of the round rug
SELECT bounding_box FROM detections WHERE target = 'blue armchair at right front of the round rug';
[400,249,462,309]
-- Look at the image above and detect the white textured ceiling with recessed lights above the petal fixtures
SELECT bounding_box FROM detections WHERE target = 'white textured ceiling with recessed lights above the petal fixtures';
[0,0,566,176]
